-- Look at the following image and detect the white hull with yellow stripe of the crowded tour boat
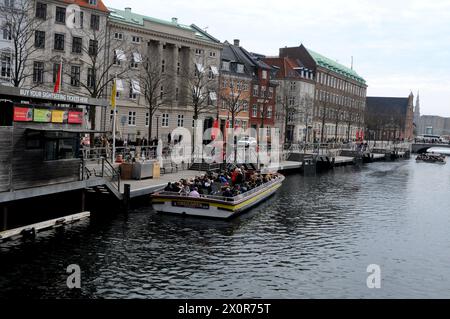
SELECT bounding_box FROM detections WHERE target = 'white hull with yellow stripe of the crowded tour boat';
[152,177,284,219]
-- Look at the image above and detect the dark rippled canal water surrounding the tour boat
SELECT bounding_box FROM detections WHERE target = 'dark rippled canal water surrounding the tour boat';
[0,160,450,298]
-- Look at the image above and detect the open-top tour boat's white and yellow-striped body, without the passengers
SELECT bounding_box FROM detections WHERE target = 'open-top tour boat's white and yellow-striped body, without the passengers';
[152,174,285,219]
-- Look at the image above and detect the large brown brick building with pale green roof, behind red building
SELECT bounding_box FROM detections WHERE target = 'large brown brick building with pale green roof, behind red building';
[280,44,367,141]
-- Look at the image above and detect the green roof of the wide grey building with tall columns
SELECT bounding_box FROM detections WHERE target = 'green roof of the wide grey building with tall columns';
[108,8,217,42]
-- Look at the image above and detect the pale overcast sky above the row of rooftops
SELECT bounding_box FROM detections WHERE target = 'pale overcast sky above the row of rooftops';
[104,0,450,116]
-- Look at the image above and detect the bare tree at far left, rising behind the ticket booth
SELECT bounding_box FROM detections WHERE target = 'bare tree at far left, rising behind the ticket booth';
[0,0,50,87]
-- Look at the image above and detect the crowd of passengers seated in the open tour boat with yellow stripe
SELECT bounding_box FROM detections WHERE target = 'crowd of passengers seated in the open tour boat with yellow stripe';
[164,167,276,198]
